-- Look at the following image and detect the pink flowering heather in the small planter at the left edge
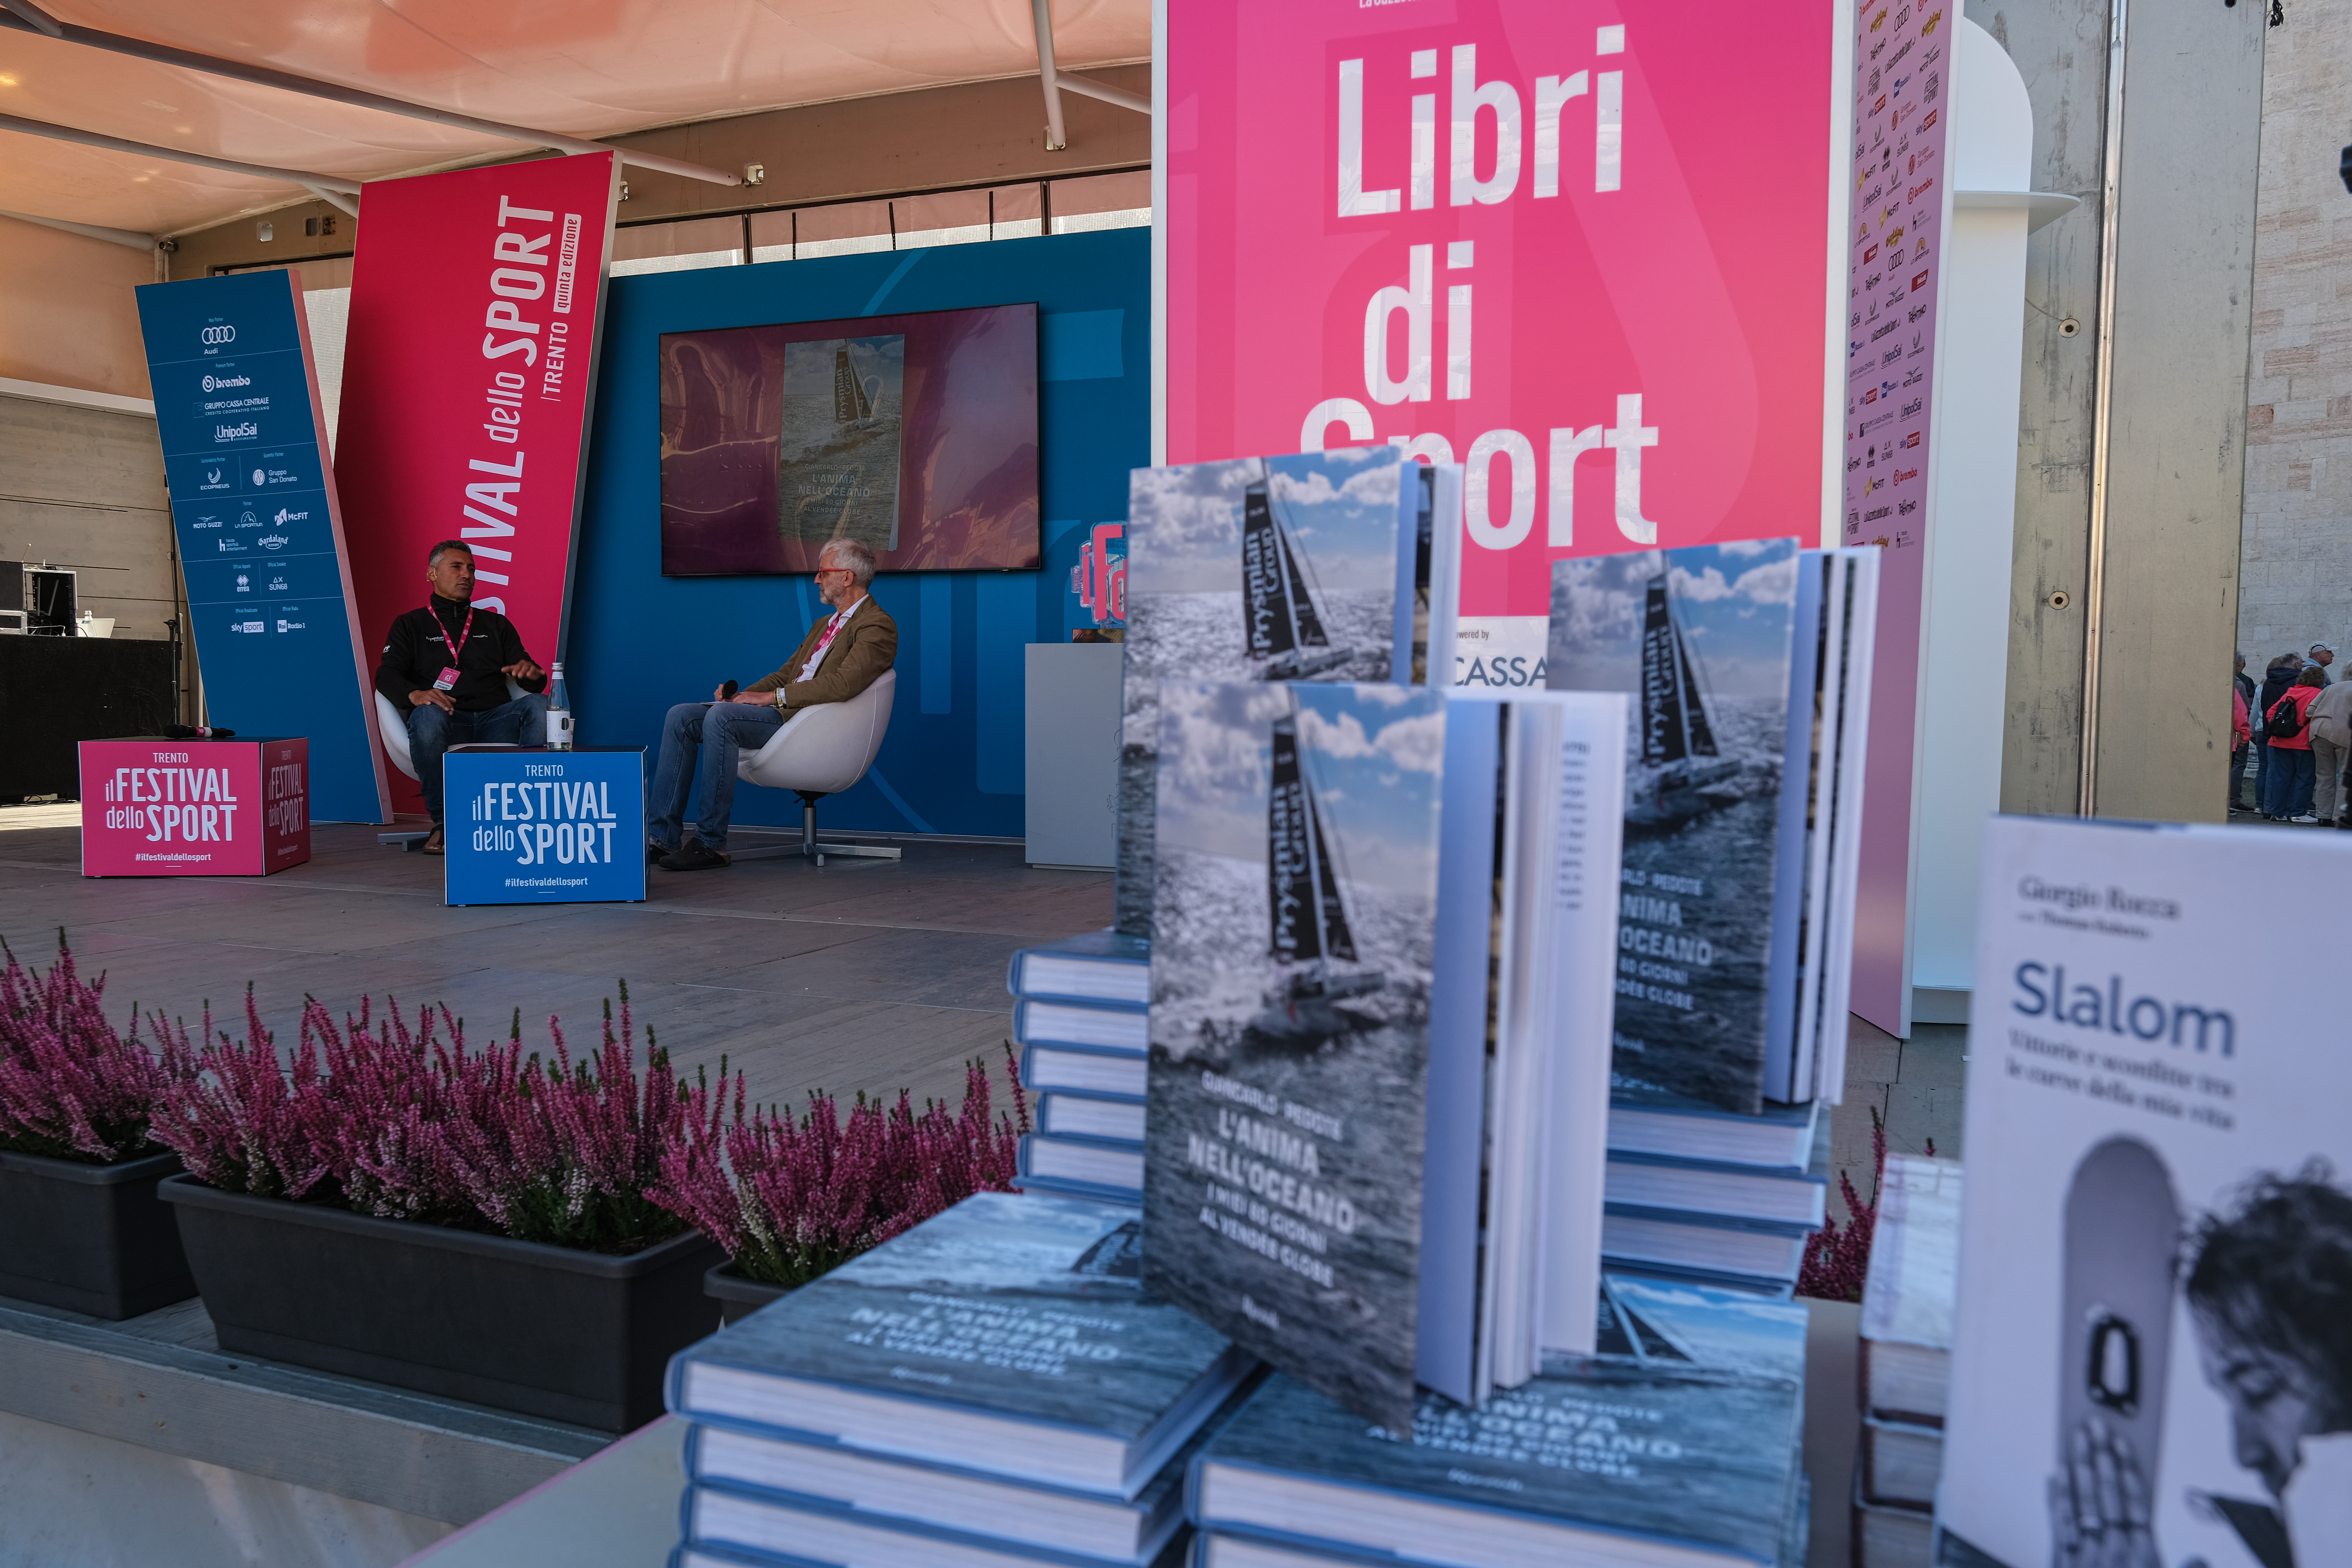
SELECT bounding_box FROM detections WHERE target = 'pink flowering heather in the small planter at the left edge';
[0,931,179,1166]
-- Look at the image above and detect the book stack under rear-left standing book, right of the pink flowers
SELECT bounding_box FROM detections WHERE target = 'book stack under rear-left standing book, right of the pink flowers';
[1004,929,1153,1204]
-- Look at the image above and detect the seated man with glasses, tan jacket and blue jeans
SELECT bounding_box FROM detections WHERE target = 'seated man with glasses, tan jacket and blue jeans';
[645,538,899,872]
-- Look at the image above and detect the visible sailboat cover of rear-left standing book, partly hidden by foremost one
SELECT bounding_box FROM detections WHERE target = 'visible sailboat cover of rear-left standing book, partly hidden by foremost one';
[1115,447,1423,936]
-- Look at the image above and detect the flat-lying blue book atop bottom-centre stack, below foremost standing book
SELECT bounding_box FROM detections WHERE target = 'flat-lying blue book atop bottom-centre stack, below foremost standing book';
[1193,1359,1802,1563]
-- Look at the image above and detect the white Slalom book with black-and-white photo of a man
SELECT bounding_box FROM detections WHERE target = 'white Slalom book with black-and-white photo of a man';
[1938,818,2352,1568]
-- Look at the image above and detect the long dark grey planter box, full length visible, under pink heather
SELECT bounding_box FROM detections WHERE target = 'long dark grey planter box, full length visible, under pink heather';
[162,1175,722,1432]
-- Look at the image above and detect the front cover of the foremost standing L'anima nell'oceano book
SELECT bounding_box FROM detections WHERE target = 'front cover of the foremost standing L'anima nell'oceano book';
[1143,682,1449,1429]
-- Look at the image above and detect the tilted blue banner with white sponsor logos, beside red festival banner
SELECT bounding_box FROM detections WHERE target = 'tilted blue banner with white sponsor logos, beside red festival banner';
[139,273,390,823]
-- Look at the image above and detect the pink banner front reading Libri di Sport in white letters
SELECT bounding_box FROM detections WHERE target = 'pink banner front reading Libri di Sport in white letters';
[1162,0,1851,686]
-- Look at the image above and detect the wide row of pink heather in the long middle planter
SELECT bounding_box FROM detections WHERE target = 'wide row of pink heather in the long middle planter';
[155,983,689,1253]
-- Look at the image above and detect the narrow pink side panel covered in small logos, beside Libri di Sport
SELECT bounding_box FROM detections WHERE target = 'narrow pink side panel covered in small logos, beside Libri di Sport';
[1844,0,1959,1034]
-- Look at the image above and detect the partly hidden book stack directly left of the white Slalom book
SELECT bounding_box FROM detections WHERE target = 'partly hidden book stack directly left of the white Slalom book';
[1853,1154,1959,1568]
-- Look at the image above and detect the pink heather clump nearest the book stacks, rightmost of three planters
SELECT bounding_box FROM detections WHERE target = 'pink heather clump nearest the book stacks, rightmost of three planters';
[649,1046,1030,1286]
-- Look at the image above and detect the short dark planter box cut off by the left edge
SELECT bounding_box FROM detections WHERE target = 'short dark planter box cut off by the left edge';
[0,1152,195,1319]
